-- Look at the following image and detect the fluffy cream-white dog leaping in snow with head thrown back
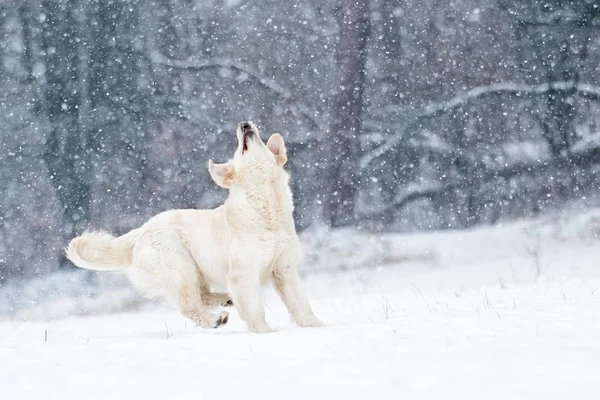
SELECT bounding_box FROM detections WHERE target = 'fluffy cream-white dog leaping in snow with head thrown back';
[66,122,323,332]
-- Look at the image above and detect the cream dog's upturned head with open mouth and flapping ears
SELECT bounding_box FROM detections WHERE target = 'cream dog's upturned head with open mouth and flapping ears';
[208,122,287,189]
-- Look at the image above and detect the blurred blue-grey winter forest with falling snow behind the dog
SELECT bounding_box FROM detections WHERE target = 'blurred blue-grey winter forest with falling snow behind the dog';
[0,0,600,285]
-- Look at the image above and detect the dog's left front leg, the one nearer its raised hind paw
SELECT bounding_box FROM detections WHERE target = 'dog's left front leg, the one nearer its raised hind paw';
[227,252,273,333]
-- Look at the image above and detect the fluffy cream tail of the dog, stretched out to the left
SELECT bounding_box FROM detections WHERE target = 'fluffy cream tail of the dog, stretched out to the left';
[66,230,138,271]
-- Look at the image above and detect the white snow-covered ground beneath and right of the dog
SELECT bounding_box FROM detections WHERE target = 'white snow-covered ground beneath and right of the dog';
[0,213,600,400]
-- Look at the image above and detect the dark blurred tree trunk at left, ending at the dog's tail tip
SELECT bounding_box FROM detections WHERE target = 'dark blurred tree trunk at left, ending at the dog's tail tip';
[42,0,90,266]
